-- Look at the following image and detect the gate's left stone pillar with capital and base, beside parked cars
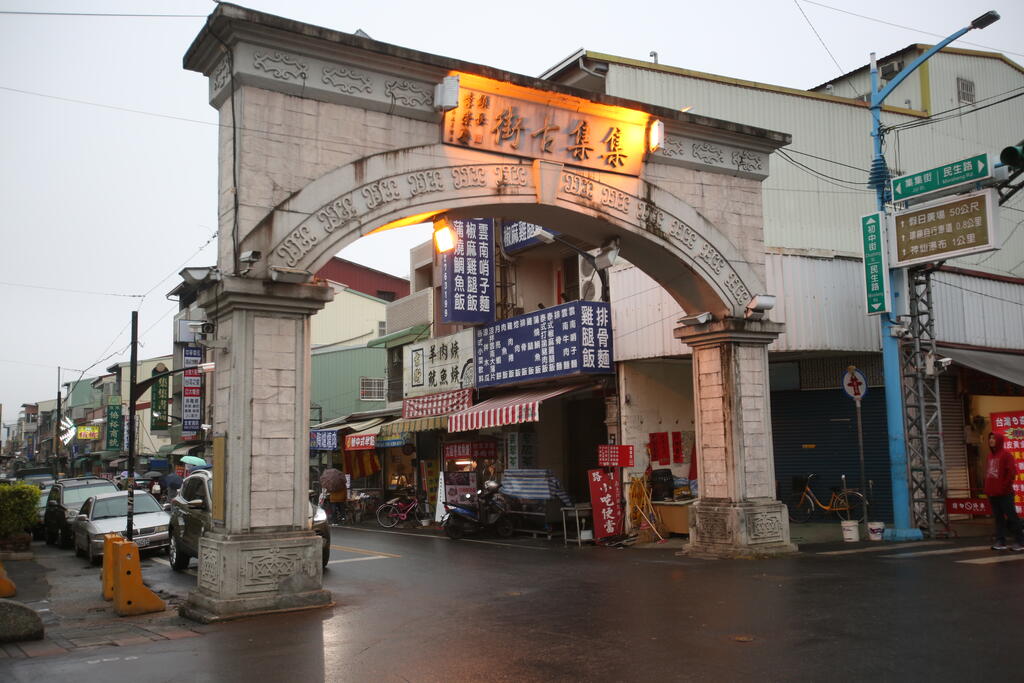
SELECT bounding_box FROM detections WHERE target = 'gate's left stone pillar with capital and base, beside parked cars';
[180,276,334,622]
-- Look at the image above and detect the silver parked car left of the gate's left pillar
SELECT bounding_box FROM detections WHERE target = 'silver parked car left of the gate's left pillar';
[72,490,171,564]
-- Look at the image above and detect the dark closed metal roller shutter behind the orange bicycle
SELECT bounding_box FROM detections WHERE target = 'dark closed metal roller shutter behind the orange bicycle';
[771,388,892,522]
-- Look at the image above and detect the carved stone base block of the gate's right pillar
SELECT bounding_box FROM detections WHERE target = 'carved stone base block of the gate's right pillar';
[686,499,797,557]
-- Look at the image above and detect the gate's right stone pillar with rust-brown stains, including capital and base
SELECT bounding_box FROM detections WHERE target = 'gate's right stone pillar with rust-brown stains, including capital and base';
[675,318,797,557]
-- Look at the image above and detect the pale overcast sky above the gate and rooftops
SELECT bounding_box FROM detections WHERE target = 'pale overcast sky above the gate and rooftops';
[0,0,1024,432]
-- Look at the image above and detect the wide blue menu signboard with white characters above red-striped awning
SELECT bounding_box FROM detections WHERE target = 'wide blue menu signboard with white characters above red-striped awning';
[476,301,612,387]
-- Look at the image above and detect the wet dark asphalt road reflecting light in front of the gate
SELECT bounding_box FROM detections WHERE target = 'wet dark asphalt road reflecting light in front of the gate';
[0,527,1024,682]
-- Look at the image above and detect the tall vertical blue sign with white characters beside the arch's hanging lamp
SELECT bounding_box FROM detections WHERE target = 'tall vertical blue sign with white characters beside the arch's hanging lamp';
[441,218,495,323]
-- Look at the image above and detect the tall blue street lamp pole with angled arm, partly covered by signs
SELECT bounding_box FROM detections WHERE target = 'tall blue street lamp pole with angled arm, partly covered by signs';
[868,5,999,541]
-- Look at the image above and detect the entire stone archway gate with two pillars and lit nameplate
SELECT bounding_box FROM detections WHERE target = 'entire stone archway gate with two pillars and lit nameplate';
[183,4,793,620]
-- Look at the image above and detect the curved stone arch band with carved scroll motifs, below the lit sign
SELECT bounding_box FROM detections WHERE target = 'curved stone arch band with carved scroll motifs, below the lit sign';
[240,144,765,318]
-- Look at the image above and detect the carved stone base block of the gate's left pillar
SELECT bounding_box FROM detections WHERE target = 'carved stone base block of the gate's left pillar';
[178,531,334,624]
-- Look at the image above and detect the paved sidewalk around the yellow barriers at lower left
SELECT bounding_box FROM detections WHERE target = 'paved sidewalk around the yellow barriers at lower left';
[0,542,204,661]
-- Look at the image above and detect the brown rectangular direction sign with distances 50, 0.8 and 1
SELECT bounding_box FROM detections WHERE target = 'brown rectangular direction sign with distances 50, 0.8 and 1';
[893,190,998,266]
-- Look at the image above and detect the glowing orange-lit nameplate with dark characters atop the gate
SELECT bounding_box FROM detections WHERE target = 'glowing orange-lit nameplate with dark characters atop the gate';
[444,87,647,175]
